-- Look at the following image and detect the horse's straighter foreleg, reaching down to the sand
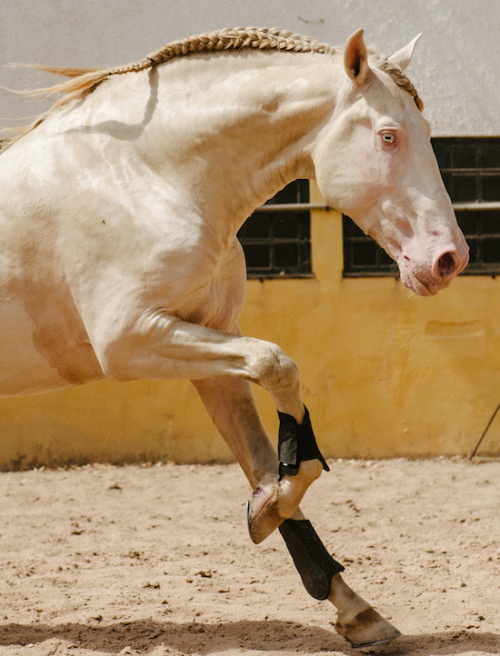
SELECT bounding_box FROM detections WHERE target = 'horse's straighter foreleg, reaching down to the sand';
[193,378,399,646]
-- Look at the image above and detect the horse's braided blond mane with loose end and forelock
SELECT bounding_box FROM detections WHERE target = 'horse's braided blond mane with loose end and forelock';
[2,27,423,150]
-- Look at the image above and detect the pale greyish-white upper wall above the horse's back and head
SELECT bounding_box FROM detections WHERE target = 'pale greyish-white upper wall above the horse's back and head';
[0,0,500,136]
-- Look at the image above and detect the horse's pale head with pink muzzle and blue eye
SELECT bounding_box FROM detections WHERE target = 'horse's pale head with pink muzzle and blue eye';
[313,30,468,295]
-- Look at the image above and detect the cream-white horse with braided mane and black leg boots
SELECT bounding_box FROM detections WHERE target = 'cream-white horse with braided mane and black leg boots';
[0,28,468,647]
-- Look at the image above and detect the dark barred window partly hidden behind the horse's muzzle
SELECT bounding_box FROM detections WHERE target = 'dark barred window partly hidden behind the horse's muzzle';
[343,137,500,277]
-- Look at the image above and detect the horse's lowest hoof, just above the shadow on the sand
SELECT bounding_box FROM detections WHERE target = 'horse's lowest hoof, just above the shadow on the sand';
[335,608,401,649]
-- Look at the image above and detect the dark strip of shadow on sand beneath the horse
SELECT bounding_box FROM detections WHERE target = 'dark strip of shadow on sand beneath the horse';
[0,620,500,656]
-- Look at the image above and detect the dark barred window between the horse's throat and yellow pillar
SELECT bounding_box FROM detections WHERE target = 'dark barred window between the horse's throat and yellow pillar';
[238,180,312,278]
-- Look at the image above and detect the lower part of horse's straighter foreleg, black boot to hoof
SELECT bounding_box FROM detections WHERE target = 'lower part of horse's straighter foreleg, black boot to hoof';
[279,519,400,647]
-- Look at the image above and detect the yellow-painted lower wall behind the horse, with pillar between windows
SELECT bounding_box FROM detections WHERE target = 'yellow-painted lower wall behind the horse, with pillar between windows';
[0,184,500,468]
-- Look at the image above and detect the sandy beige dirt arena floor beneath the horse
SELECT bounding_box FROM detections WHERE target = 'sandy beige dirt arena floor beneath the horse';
[0,459,500,656]
